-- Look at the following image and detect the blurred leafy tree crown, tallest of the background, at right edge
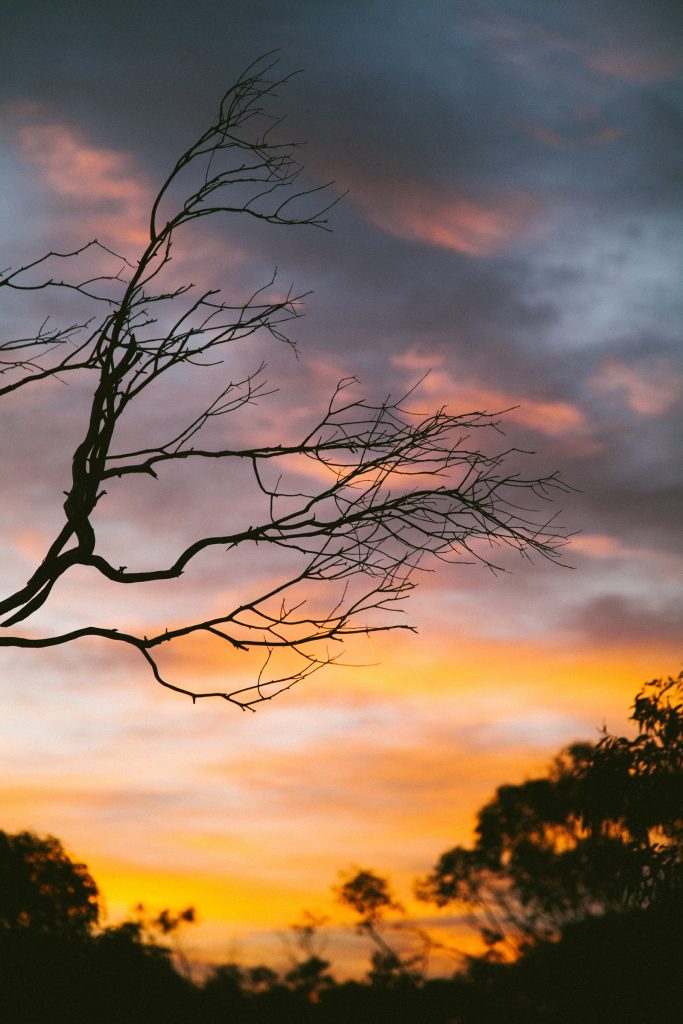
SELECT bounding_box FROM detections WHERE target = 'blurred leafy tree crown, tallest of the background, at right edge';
[419,675,683,954]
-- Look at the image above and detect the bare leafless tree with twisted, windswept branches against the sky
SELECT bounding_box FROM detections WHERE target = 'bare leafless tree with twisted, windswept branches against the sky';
[0,59,563,708]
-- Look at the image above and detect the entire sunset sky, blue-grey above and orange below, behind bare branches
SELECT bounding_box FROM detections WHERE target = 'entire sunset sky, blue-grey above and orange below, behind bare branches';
[0,0,683,970]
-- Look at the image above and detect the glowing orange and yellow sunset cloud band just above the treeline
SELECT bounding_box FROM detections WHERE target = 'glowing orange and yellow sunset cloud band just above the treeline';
[0,622,675,971]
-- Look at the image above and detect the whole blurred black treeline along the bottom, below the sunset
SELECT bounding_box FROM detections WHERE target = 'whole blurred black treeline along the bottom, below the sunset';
[0,674,683,1024]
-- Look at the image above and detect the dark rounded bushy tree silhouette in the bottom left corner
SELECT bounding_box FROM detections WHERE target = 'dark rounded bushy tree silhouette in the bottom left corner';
[0,831,199,1024]
